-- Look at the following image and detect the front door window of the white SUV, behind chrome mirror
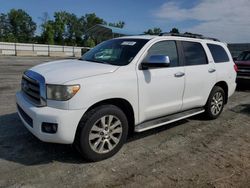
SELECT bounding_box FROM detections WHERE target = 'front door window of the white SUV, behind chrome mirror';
[145,41,179,67]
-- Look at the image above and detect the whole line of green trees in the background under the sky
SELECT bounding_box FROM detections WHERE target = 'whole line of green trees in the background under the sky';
[0,9,179,47]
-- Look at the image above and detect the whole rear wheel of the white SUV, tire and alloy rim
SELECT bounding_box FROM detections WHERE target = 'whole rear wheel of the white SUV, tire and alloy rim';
[205,86,226,119]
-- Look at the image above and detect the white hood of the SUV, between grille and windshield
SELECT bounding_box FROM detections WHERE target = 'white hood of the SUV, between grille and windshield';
[30,59,119,84]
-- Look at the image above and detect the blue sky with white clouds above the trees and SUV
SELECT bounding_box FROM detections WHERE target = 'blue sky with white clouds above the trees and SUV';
[0,0,250,43]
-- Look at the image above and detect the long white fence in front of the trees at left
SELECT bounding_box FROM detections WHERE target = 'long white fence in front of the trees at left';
[0,42,89,57]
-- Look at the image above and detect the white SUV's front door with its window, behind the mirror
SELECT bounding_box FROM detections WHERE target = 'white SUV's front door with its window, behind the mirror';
[137,41,184,121]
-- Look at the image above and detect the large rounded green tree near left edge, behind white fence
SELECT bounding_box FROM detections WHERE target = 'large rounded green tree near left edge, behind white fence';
[7,9,36,42]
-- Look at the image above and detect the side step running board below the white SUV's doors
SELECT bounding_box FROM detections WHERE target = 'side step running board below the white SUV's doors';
[135,108,205,132]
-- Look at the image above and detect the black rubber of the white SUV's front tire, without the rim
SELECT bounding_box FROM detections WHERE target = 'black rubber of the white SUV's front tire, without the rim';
[79,105,128,161]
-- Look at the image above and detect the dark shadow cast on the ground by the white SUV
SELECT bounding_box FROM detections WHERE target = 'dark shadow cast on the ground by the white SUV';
[0,113,188,166]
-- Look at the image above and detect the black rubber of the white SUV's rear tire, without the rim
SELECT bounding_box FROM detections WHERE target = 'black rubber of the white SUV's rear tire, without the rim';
[205,86,226,119]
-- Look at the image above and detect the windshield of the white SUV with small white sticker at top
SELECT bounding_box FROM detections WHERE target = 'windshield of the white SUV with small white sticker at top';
[80,39,148,66]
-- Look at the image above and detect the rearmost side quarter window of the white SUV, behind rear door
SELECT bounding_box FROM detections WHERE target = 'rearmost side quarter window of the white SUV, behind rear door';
[207,44,229,63]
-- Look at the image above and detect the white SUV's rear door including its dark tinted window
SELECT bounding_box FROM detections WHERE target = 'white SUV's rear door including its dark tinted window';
[181,41,216,110]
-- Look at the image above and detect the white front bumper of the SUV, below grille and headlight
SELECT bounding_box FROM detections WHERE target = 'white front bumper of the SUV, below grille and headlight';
[16,92,85,144]
